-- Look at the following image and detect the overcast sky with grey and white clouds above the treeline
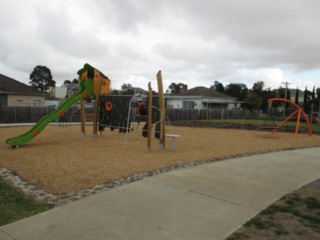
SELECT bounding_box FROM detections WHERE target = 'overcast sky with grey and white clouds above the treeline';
[0,0,320,90]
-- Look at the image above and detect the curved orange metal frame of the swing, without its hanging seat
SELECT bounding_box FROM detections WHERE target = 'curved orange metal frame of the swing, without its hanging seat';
[268,98,312,137]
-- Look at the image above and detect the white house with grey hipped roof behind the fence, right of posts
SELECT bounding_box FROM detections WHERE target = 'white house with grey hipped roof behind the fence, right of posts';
[165,87,237,109]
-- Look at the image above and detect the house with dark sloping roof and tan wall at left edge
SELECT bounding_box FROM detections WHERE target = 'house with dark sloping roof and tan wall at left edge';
[0,74,45,107]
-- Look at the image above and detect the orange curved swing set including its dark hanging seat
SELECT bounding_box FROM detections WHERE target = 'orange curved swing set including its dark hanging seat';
[261,98,312,137]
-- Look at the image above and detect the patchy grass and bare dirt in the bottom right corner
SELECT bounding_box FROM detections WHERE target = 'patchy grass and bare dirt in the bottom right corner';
[226,179,320,240]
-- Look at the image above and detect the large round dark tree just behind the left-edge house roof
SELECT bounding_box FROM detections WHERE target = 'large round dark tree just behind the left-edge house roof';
[29,66,56,93]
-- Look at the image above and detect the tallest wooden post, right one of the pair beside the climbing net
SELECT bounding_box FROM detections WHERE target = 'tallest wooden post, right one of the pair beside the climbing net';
[157,71,166,149]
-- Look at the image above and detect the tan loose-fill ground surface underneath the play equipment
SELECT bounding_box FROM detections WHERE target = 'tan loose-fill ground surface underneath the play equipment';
[0,124,320,193]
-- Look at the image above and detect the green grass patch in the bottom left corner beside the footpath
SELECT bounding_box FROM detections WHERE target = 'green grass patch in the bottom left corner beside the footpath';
[0,179,49,226]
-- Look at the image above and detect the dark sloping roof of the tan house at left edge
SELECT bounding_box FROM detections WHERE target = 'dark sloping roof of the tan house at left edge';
[0,74,43,95]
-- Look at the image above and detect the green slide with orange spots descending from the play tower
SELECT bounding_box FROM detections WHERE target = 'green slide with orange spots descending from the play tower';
[6,79,93,146]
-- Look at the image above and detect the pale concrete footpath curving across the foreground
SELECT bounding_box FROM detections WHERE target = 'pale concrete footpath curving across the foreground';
[0,148,320,240]
